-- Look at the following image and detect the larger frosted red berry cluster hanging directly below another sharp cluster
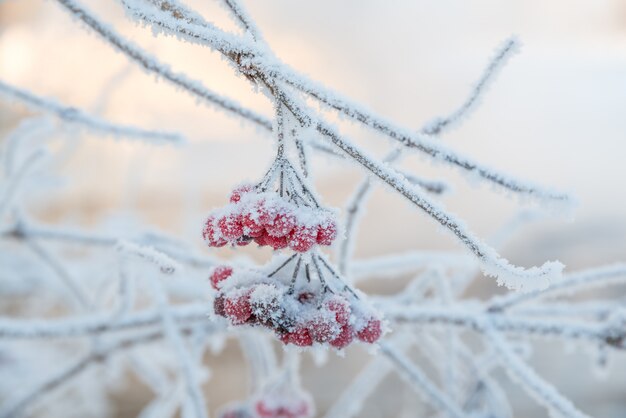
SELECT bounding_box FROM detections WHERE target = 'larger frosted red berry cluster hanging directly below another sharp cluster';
[210,266,383,349]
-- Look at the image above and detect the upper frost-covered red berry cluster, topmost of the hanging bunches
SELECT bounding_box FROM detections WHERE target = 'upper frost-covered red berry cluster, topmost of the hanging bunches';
[202,186,337,253]
